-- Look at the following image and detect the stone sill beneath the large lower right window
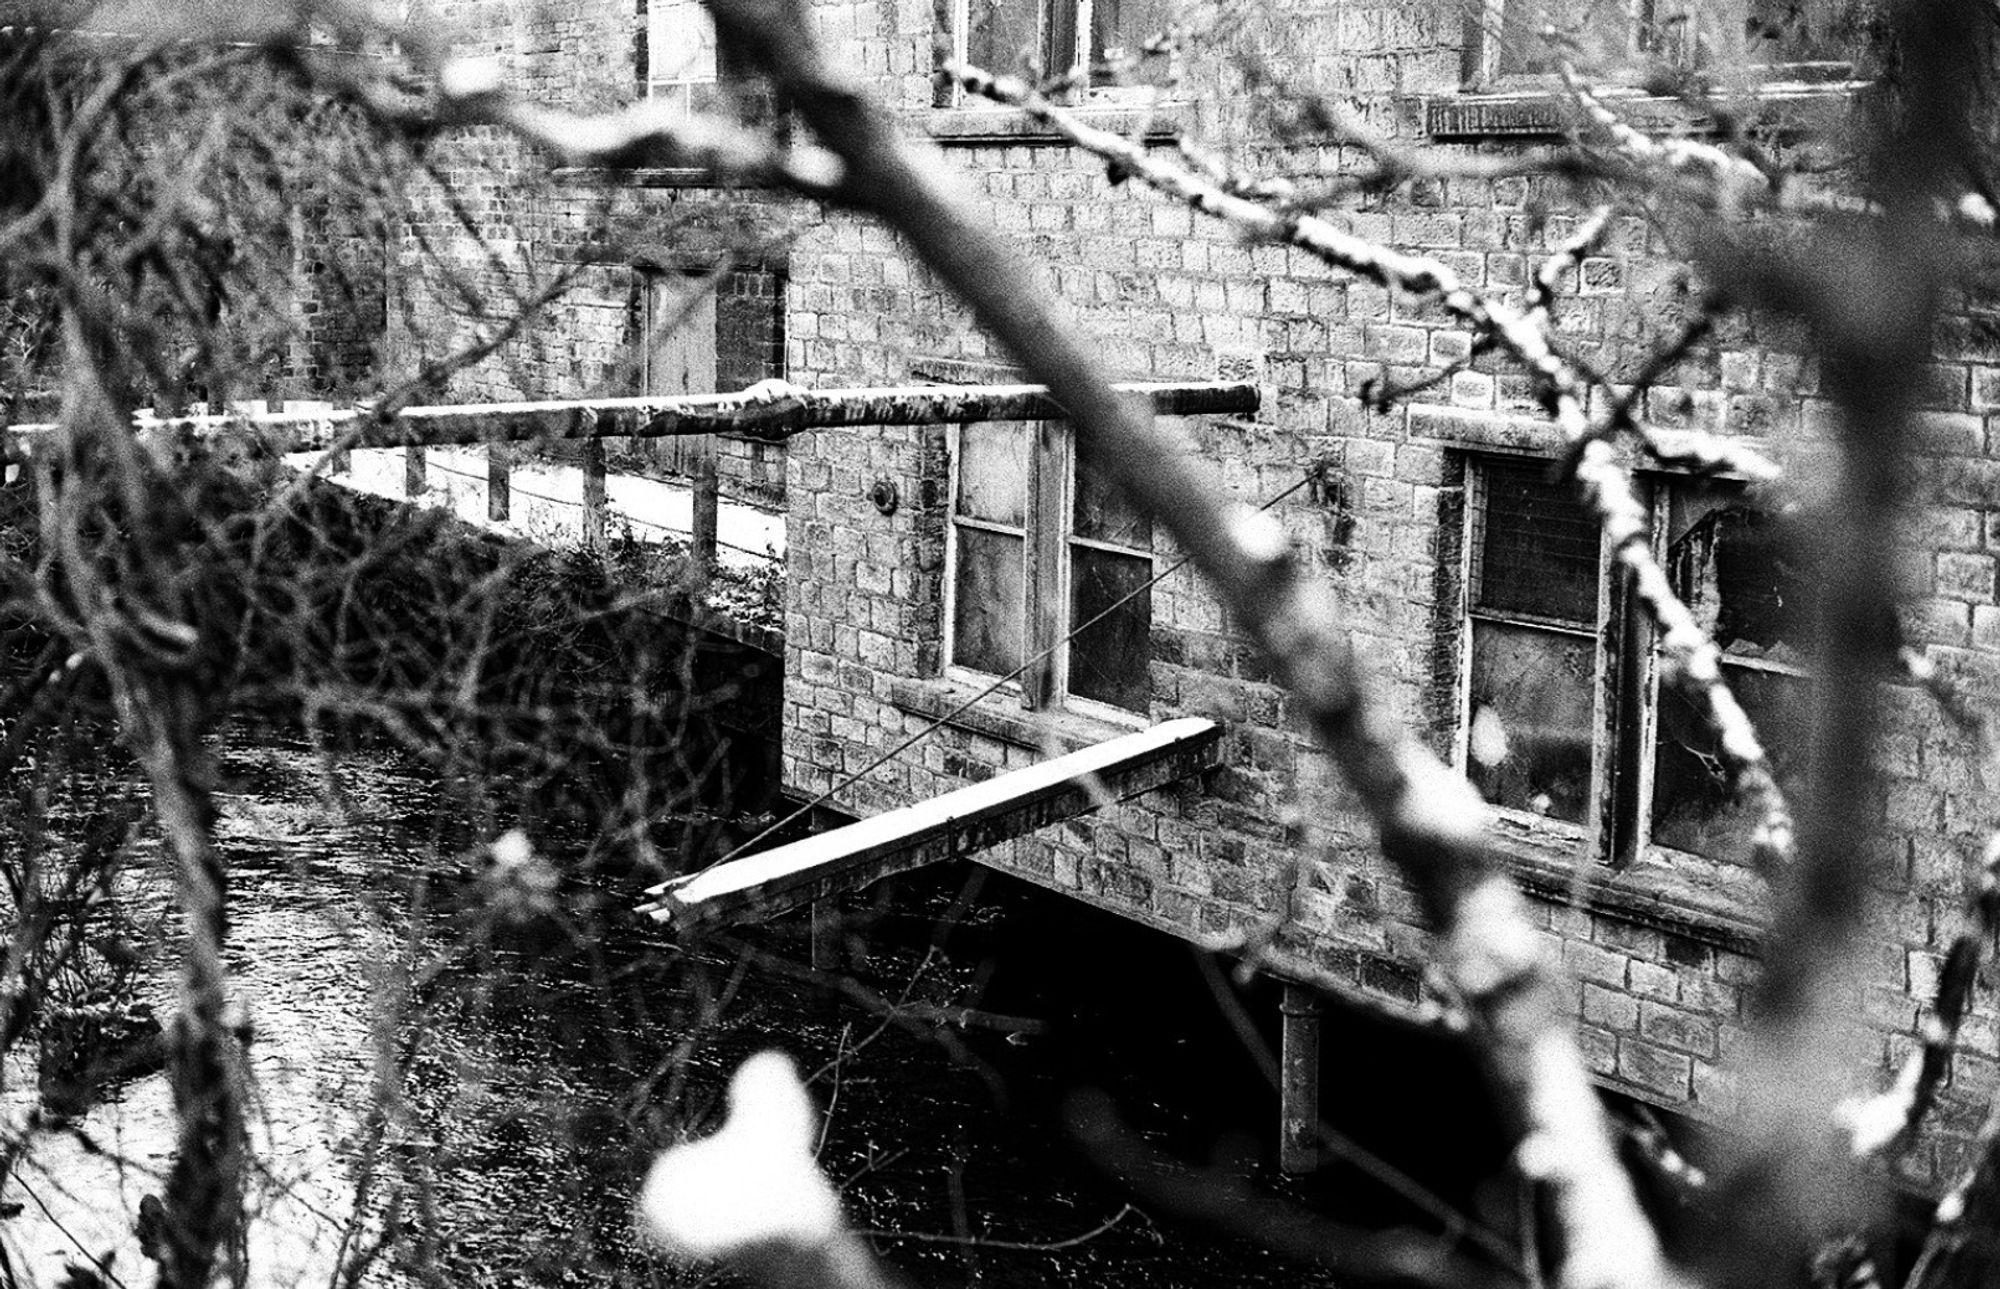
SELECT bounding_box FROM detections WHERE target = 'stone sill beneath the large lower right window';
[1494,815,1770,957]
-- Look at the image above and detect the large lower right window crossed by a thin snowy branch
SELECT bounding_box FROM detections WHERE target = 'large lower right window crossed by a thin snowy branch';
[1462,460,1810,863]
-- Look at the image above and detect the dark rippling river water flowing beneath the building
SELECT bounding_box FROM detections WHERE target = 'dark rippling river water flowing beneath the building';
[0,731,1498,1287]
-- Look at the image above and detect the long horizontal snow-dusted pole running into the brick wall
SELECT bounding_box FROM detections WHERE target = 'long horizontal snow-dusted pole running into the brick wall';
[0,380,1258,460]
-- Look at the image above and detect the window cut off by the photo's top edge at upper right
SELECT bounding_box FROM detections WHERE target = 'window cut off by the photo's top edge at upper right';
[1472,0,1852,84]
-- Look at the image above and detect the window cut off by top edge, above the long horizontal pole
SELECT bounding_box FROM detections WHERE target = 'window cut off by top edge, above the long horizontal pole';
[936,0,1176,106]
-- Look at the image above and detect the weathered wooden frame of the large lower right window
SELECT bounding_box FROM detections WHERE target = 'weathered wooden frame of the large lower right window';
[1452,450,1812,871]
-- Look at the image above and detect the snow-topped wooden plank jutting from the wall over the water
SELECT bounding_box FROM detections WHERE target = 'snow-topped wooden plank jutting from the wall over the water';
[640,717,1222,927]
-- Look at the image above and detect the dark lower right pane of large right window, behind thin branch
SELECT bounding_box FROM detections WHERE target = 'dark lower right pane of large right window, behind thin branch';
[1652,667,1812,863]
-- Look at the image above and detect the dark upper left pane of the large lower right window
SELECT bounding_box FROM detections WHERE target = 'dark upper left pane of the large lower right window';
[1472,462,1600,626]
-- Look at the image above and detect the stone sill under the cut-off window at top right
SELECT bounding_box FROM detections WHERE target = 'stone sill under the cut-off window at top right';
[1424,80,1866,138]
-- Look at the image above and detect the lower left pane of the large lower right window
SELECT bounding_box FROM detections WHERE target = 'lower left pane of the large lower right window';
[1466,620,1596,823]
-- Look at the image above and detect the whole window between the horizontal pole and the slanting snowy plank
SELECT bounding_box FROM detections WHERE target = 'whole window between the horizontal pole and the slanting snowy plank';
[946,422,1154,715]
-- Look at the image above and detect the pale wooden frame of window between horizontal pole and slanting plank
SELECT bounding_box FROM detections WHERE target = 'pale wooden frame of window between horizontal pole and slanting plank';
[940,420,1160,729]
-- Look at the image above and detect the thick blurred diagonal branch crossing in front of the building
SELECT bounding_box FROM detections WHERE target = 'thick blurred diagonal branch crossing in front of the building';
[604,0,1672,1287]
